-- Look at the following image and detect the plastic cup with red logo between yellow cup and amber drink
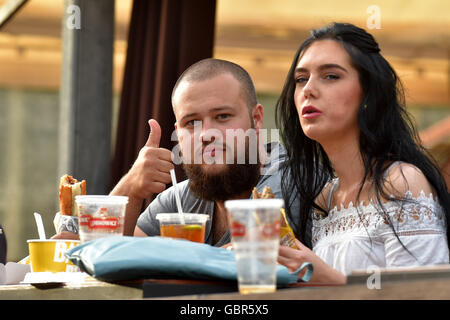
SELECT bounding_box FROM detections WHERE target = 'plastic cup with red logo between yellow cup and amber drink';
[75,195,128,243]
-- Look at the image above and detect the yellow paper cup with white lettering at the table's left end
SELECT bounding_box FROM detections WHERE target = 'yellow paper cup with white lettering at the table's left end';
[27,239,80,272]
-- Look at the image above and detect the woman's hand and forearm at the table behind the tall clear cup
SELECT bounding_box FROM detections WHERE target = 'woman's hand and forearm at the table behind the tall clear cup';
[278,239,347,284]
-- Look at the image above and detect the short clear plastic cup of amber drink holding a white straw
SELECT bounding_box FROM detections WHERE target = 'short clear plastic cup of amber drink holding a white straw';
[156,213,209,243]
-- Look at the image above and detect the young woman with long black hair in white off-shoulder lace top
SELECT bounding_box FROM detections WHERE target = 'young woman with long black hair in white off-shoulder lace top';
[276,23,450,283]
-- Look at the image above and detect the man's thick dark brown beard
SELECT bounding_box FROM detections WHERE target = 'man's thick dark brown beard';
[183,163,261,201]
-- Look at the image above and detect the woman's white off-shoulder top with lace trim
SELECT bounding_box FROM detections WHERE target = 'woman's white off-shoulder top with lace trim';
[312,180,449,275]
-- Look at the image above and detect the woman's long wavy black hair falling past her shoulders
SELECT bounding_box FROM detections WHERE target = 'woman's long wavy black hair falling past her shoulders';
[275,23,450,249]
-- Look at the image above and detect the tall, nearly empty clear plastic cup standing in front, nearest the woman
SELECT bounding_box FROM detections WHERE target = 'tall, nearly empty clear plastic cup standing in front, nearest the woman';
[225,199,284,294]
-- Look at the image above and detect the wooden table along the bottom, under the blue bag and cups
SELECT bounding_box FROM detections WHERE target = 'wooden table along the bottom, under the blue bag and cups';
[0,267,450,301]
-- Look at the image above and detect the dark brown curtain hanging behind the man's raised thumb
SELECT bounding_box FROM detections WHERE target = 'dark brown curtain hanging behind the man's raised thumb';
[111,0,216,192]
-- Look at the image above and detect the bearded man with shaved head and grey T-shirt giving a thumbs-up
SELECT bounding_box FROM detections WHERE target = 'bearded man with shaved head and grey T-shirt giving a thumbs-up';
[54,59,300,246]
